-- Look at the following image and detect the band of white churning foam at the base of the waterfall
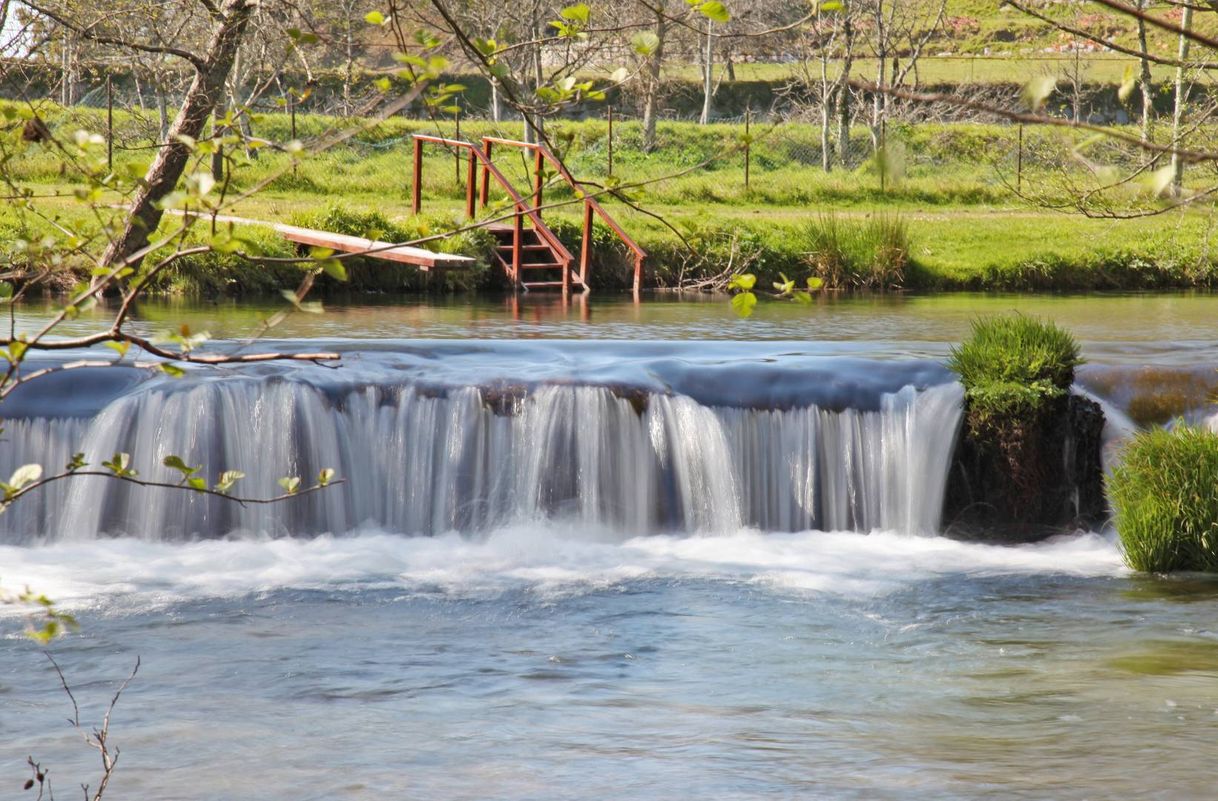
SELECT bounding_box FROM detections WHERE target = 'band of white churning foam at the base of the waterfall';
[0,522,1125,610]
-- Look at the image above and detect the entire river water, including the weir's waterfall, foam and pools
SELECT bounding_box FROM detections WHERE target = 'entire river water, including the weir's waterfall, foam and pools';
[0,295,1218,801]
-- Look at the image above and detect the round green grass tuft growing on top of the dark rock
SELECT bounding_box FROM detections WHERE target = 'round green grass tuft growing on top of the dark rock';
[948,314,1082,416]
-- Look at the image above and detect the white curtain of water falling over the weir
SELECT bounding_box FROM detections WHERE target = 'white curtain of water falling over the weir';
[0,376,961,542]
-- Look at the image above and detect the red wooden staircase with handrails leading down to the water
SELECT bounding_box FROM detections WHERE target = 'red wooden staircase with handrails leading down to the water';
[412,134,647,295]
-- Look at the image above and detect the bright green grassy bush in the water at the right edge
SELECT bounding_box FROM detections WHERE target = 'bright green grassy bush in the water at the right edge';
[1107,426,1218,572]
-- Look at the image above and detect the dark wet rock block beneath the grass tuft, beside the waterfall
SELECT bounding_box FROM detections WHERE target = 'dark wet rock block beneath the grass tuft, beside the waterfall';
[943,396,1107,543]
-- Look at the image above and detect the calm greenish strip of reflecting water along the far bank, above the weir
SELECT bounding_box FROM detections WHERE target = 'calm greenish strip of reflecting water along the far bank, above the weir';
[7,288,1218,360]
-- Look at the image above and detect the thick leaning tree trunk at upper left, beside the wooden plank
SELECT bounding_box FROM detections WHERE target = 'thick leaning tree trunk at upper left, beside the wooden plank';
[101,0,258,267]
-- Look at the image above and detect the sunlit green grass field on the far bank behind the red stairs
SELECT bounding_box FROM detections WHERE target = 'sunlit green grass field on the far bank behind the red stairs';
[9,102,1218,291]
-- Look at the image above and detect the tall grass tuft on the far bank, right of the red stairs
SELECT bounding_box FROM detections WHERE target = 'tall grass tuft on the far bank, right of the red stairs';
[799,214,910,290]
